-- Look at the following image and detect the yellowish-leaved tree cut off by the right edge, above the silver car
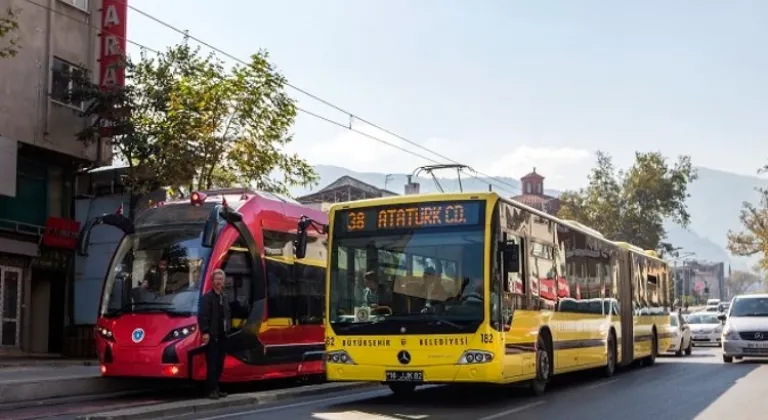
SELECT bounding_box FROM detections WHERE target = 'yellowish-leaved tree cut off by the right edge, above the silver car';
[728,165,768,270]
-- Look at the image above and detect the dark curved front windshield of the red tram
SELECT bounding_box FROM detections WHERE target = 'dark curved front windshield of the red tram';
[100,223,211,316]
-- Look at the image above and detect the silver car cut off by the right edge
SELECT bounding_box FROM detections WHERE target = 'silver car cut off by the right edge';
[718,294,768,363]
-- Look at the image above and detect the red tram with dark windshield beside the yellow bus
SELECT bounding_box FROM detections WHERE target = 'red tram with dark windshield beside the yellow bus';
[78,189,328,382]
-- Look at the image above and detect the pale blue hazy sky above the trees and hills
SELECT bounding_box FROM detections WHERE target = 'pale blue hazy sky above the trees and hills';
[123,0,768,190]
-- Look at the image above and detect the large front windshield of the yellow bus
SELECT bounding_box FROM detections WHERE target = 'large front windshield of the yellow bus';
[328,202,485,335]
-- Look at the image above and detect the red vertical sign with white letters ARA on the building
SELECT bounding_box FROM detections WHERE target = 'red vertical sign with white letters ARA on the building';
[99,0,128,137]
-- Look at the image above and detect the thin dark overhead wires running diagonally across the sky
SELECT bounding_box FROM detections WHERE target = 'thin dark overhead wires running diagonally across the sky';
[23,0,521,193]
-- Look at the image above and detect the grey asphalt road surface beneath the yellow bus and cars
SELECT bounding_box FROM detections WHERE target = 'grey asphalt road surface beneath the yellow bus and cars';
[0,348,768,420]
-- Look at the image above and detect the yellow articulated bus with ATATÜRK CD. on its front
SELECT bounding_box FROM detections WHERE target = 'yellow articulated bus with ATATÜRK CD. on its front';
[296,192,671,394]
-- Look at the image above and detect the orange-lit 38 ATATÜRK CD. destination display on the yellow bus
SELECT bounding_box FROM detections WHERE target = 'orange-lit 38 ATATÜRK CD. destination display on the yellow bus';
[336,201,484,232]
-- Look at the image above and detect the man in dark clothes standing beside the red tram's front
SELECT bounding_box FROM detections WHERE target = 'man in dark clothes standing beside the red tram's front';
[198,269,231,400]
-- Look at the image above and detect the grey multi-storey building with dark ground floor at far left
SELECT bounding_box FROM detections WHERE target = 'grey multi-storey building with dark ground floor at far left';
[0,0,121,355]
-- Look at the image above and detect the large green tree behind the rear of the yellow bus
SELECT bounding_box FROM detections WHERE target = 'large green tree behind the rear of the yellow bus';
[558,151,697,254]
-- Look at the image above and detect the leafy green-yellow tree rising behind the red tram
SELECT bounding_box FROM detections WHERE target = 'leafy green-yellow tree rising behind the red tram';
[76,43,317,210]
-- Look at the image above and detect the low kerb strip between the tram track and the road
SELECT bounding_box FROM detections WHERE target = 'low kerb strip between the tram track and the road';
[77,382,380,420]
